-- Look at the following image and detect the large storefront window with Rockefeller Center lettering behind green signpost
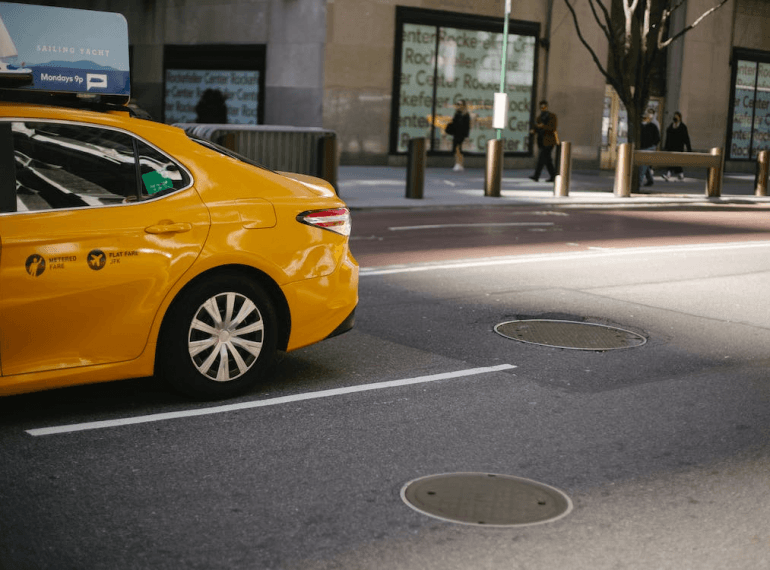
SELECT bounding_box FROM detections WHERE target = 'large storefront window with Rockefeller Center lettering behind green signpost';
[392,9,537,154]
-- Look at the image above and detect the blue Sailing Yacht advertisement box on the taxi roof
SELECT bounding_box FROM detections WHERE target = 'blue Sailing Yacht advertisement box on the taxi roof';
[0,2,131,101]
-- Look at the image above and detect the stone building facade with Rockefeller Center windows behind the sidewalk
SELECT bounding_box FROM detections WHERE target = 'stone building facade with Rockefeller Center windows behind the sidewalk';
[27,0,770,171]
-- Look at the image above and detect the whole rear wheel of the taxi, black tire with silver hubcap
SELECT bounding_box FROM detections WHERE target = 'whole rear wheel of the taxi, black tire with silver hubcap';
[156,272,278,399]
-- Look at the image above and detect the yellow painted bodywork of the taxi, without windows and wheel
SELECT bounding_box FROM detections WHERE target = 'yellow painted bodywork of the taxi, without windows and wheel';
[0,103,358,395]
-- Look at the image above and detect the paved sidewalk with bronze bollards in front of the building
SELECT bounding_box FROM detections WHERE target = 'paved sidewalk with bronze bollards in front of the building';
[337,166,770,209]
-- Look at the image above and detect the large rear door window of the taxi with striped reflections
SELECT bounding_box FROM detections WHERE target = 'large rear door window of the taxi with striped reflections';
[11,121,138,212]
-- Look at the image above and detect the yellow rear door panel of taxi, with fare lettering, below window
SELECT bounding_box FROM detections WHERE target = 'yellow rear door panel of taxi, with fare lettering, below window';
[0,189,209,376]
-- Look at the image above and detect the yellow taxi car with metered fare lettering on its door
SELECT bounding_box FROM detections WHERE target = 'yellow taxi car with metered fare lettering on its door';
[0,101,358,398]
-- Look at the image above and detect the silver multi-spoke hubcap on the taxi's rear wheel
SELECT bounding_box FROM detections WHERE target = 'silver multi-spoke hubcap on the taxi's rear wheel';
[187,293,264,382]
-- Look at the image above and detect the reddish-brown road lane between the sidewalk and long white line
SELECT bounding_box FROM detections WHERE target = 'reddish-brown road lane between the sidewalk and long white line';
[351,205,770,267]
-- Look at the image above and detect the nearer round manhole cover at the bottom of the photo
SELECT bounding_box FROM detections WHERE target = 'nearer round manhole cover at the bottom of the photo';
[401,473,572,526]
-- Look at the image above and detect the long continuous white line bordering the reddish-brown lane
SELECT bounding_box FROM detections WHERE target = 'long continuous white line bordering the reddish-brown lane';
[360,241,770,277]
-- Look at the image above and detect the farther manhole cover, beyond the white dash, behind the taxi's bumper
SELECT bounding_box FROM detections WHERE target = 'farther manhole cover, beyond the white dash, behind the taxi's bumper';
[495,319,647,350]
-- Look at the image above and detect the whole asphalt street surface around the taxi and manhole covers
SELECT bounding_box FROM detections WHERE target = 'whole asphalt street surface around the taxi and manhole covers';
[0,208,770,570]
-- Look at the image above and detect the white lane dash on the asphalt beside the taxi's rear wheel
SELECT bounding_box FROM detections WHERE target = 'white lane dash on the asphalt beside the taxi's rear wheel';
[26,364,516,436]
